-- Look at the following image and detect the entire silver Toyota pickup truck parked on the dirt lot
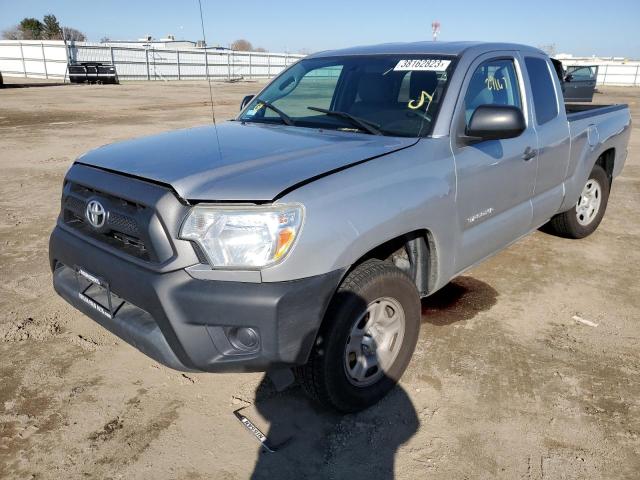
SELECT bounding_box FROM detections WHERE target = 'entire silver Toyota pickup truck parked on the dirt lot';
[50,42,630,412]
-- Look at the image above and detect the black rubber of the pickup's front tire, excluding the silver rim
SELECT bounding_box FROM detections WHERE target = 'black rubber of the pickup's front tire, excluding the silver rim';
[295,260,421,413]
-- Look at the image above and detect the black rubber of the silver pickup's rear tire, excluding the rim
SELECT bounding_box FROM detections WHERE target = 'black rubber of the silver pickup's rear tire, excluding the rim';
[543,165,610,238]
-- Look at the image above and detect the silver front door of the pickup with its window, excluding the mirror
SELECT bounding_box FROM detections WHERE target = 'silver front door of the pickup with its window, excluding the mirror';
[451,52,537,272]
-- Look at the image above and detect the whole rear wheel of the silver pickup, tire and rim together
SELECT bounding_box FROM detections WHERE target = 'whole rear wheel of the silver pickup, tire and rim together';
[545,165,609,238]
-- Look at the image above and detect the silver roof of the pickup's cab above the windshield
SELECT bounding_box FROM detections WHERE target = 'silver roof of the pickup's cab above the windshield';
[307,42,544,58]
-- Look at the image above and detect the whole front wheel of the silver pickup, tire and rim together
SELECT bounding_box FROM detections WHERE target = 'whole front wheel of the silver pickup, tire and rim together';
[296,260,421,413]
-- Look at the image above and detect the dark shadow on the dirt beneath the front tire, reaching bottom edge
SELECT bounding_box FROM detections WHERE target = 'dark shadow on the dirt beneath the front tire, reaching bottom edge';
[246,376,419,480]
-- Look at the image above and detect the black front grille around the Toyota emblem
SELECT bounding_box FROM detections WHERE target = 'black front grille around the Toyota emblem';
[62,183,157,261]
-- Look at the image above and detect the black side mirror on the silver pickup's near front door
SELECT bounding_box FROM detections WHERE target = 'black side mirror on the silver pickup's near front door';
[465,105,527,140]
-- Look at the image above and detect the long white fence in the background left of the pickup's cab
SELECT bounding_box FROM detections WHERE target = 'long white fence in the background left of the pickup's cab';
[0,40,303,80]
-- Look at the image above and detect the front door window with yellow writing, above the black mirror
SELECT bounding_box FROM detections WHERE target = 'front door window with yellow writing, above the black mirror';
[464,59,522,124]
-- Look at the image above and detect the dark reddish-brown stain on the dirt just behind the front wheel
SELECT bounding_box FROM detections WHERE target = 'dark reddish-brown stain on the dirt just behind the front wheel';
[422,276,498,327]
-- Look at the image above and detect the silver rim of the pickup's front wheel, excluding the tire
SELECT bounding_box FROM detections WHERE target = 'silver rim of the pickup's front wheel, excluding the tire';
[343,297,405,387]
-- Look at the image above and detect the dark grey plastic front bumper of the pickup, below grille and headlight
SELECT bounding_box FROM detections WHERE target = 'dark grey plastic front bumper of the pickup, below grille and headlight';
[49,227,343,372]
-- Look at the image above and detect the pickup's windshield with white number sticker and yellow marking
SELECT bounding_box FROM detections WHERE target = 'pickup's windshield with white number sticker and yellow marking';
[238,54,454,137]
